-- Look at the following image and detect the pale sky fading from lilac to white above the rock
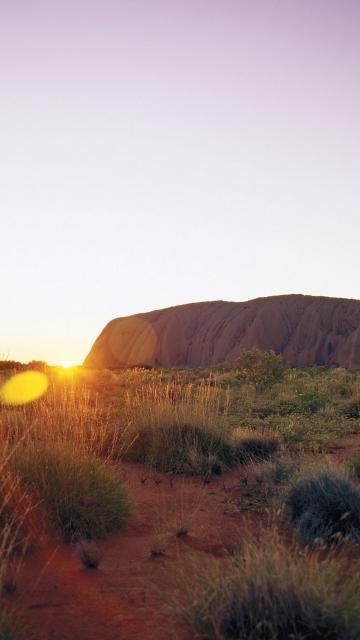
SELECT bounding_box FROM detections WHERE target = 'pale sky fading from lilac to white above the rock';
[0,0,360,364]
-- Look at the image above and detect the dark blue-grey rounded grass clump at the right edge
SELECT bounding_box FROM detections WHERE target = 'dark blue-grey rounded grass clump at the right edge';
[285,464,360,545]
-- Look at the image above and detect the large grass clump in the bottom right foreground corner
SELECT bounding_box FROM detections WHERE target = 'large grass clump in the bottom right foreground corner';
[177,532,360,640]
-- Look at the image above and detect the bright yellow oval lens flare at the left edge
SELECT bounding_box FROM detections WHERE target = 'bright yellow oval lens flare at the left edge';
[0,371,49,405]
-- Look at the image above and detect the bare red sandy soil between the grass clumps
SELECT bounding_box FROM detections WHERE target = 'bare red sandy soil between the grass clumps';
[4,438,360,640]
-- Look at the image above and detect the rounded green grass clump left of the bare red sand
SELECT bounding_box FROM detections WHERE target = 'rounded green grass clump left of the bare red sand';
[9,443,131,542]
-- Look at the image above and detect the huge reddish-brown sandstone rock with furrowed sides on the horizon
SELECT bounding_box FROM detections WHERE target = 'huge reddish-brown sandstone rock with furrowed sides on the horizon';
[84,295,360,368]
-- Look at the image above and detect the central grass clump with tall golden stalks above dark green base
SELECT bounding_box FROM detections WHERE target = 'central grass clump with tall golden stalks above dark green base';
[126,382,236,474]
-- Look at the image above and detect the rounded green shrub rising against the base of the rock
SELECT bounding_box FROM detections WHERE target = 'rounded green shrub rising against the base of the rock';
[236,349,286,391]
